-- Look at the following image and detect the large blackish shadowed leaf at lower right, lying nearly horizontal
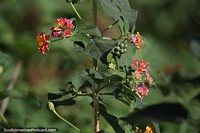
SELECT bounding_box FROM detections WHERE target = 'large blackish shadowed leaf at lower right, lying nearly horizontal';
[122,103,188,124]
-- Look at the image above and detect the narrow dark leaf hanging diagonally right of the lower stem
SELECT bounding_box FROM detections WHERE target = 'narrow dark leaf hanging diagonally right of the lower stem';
[90,102,125,133]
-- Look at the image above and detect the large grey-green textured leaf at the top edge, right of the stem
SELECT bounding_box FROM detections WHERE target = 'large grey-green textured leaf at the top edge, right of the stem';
[100,0,137,34]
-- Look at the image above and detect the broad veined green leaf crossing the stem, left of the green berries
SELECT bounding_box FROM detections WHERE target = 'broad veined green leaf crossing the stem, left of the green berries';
[74,38,117,64]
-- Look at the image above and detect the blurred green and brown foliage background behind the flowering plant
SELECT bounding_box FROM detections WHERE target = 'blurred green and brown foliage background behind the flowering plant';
[0,0,200,133]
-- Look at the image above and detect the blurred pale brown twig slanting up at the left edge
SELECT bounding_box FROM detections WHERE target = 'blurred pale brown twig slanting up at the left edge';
[0,61,22,114]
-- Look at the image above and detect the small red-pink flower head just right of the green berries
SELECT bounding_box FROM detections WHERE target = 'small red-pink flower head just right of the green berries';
[131,32,144,50]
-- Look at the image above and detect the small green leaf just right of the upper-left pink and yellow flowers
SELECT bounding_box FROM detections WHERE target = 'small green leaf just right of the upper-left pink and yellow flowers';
[78,26,101,36]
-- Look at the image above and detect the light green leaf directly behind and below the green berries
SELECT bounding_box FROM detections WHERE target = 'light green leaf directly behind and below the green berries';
[116,42,136,68]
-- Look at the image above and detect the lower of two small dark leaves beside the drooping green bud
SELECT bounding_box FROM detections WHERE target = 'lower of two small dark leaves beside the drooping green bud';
[51,98,76,107]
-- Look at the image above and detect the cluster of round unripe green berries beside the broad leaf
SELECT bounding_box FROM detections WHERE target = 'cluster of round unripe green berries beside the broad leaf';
[112,41,128,56]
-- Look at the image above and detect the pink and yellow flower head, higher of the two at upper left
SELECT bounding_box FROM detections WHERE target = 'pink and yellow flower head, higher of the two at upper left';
[51,18,75,38]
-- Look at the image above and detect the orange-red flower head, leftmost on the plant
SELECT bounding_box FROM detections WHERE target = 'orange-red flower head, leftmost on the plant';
[36,32,50,54]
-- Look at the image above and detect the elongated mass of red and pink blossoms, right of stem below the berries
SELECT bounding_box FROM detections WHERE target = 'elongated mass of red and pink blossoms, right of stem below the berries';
[132,59,153,98]
